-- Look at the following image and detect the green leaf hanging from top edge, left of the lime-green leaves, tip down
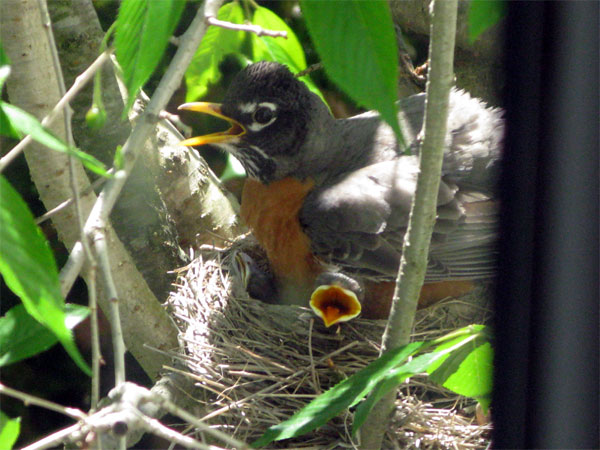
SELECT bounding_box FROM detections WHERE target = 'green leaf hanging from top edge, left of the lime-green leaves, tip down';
[115,0,185,112]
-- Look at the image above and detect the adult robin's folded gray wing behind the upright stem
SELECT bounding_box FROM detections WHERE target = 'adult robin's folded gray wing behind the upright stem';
[300,157,496,281]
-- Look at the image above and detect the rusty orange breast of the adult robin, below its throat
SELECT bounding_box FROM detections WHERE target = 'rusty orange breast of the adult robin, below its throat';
[240,178,319,286]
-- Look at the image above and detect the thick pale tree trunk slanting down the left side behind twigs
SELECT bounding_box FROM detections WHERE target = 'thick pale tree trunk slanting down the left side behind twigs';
[0,0,178,378]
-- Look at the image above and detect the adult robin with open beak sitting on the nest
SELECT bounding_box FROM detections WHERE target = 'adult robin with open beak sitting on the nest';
[179,62,503,326]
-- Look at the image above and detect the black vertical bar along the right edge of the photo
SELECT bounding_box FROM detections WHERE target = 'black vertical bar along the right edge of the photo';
[493,1,600,448]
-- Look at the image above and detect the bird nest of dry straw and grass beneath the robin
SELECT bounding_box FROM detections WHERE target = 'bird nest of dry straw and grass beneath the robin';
[168,238,491,449]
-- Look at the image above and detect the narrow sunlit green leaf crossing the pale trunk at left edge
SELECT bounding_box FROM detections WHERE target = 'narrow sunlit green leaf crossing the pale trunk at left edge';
[0,101,110,177]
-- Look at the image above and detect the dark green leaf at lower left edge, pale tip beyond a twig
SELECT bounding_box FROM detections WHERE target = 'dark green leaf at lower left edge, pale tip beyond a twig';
[0,303,89,367]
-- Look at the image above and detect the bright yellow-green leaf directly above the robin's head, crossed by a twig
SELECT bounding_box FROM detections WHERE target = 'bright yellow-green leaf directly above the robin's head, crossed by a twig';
[251,7,325,101]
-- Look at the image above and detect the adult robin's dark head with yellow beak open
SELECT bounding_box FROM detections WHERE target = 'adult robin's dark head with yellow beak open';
[179,61,322,183]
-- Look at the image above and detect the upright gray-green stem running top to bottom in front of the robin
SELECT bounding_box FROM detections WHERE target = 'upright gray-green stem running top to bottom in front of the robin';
[360,0,457,449]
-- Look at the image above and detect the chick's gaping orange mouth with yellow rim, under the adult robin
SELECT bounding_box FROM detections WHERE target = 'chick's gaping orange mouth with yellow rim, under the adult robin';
[310,285,361,327]
